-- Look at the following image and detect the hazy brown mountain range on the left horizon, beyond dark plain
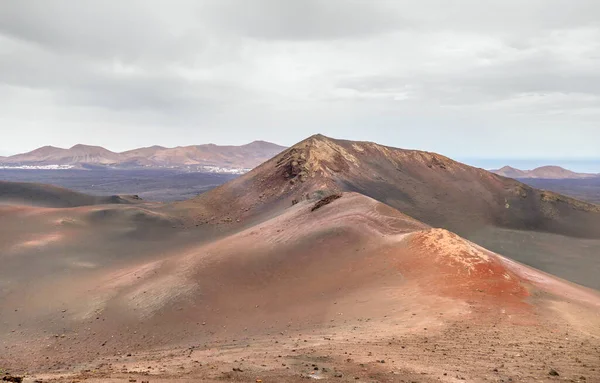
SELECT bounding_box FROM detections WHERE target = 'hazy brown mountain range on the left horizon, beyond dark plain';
[0,141,286,173]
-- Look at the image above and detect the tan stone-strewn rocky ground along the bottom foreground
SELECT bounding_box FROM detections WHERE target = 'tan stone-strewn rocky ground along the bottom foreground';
[2,302,600,382]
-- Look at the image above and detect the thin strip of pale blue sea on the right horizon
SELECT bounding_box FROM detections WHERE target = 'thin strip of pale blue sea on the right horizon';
[456,158,600,173]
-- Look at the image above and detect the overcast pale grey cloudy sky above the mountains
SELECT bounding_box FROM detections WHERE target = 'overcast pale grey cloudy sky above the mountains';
[0,0,600,168]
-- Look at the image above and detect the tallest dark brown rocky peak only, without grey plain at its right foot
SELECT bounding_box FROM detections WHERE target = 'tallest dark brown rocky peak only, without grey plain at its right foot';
[183,135,600,238]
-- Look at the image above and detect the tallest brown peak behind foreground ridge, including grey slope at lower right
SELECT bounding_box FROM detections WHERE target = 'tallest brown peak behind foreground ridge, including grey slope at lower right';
[179,136,600,289]
